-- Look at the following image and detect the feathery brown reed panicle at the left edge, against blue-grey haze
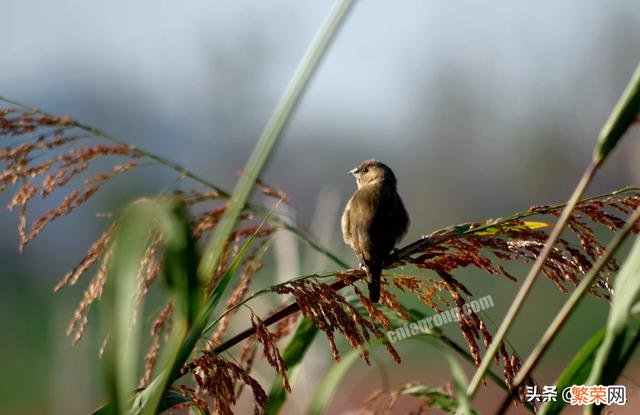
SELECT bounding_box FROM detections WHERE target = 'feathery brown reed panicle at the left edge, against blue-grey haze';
[0,108,139,251]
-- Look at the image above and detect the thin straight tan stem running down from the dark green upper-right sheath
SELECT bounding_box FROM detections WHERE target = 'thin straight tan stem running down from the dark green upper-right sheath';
[467,161,600,398]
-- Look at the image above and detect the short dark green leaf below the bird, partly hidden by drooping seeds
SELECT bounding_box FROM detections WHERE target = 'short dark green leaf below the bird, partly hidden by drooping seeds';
[265,318,318,415]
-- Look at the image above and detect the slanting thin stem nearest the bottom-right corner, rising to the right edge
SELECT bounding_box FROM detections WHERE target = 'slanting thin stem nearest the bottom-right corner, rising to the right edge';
[496,208,640,414]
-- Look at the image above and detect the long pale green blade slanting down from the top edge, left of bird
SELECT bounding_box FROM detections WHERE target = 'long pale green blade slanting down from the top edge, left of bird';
[199,0,351,281]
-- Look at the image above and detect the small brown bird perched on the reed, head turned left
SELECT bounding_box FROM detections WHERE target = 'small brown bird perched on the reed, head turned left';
[342,160,409,303]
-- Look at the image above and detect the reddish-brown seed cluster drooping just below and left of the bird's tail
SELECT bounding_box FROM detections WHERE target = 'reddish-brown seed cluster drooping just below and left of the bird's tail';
[273,279,400,364]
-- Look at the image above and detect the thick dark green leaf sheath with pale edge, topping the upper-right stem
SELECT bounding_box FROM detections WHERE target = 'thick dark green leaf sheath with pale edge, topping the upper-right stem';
[593,64,640,163]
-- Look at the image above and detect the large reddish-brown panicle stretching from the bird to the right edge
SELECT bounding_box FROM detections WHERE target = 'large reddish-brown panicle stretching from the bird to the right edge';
[406,193,640,297]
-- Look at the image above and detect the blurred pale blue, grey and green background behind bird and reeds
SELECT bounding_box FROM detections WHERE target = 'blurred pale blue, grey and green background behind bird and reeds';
[0,0,640,414]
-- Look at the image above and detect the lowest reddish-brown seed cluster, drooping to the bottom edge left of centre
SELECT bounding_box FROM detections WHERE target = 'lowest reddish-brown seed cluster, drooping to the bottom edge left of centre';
[190,353,267,415]
